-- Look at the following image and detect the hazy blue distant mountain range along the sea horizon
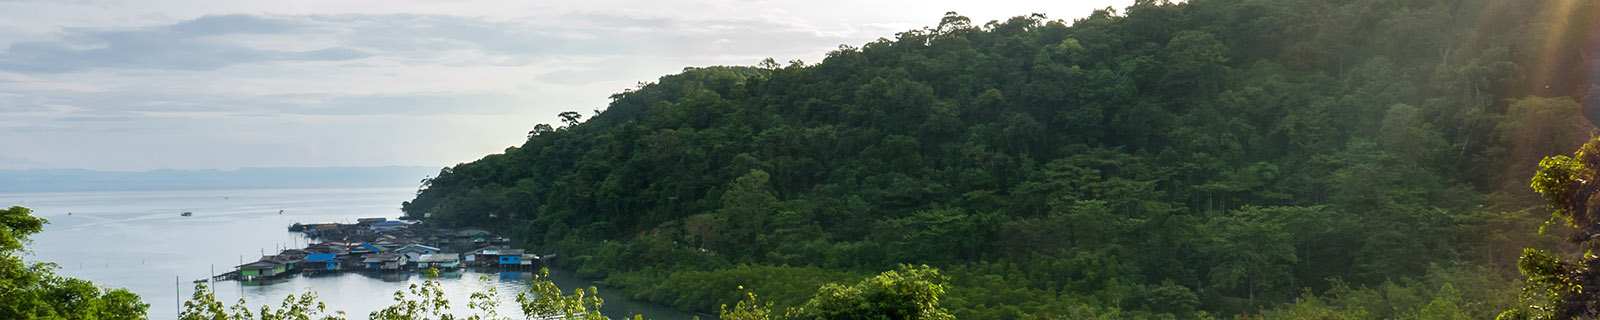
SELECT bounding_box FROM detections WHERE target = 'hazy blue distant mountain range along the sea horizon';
[0,166,438,192]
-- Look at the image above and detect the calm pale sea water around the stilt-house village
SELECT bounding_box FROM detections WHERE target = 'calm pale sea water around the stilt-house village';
[0,189,710,320]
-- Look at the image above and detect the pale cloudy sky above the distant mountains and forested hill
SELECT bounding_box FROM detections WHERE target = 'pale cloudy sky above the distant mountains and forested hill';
[0,0,1133,171]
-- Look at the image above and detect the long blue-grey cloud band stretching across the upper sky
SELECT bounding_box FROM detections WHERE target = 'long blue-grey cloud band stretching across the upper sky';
[0,13,846,74]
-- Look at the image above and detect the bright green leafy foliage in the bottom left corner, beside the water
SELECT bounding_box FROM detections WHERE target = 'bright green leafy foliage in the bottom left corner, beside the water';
[0,206,150,318]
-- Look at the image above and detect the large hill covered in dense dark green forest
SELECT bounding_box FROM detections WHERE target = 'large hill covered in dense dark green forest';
[405,0,1600,318]
